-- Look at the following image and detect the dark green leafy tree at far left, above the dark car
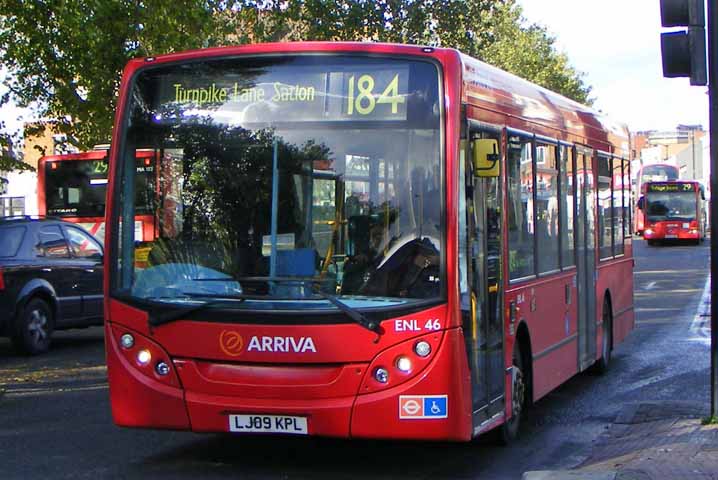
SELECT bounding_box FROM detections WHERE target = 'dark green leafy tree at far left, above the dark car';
[0,0,231,149]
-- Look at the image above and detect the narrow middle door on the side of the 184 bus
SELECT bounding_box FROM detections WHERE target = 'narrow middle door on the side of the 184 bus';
[575,146,596,370]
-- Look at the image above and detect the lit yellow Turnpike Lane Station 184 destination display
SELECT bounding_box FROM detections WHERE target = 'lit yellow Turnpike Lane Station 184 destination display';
[153,63,410,125]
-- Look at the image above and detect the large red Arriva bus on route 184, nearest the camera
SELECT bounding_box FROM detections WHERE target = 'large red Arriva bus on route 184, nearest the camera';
[105,42,634,441]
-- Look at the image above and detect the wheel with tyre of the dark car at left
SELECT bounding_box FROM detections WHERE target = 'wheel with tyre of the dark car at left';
[11,298,54,355]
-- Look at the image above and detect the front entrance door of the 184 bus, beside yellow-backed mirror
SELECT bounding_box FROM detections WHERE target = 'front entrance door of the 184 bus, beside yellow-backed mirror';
[459,124,504,430]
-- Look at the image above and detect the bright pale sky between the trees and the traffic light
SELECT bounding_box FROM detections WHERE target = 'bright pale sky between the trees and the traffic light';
[518,0,708,132]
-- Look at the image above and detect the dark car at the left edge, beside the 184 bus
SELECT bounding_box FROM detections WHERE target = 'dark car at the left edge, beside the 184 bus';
[0,217,103,354]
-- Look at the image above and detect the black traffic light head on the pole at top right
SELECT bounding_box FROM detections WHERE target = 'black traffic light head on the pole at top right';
[660,0,708,85]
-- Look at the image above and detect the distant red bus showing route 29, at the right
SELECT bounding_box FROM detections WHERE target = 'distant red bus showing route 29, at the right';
[638,180,706,245]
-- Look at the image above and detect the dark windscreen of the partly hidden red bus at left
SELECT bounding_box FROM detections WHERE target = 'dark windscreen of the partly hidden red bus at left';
[45,159,154,218]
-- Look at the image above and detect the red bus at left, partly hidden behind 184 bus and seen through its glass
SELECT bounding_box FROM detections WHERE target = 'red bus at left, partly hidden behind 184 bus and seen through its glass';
[37,148,156,242]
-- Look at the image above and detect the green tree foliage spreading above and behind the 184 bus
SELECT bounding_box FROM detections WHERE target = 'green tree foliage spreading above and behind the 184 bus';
[0,0,590,156]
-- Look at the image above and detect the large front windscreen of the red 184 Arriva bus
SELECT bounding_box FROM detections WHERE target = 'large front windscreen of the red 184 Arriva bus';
[113,55,445,310]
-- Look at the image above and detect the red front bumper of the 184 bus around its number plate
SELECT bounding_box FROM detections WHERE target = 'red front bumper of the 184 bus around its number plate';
[106,326,472,441]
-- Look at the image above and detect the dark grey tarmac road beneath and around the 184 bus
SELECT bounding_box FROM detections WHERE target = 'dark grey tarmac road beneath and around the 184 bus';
[0,241,709,479]
